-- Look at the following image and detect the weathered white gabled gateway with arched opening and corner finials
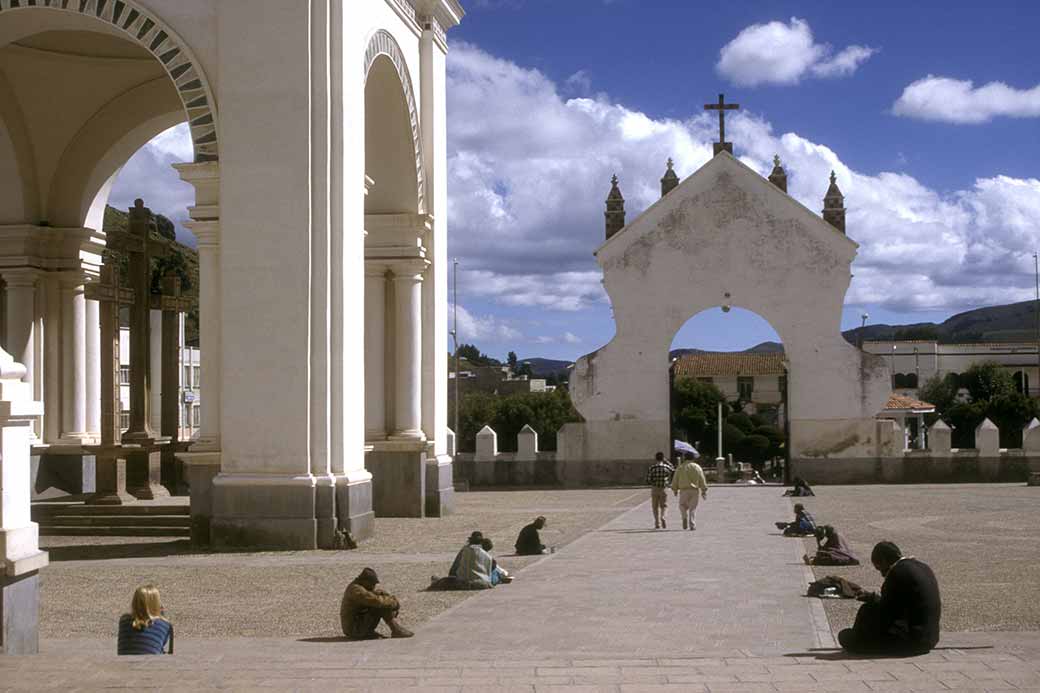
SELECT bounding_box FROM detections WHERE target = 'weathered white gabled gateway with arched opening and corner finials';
[561,151,890,478]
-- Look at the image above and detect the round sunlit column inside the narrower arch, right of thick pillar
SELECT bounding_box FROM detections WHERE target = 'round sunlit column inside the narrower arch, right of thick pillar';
[391,261,425,440]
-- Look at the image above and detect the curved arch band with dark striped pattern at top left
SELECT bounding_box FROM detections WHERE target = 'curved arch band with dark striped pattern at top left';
[0,0,219,162]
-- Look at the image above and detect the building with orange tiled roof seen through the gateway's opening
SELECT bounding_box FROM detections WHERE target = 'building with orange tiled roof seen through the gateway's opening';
[673,352,787,427]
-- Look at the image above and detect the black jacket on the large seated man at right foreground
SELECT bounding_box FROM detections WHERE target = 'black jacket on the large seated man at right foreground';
[878,558,942,650]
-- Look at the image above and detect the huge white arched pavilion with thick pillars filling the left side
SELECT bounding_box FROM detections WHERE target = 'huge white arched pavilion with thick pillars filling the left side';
[0,0,463,548]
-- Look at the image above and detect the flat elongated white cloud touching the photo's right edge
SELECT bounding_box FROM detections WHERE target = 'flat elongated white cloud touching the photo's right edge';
[892,75,1040,124]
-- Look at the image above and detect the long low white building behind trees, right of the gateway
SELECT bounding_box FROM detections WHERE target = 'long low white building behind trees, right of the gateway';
[863,340,1040,397]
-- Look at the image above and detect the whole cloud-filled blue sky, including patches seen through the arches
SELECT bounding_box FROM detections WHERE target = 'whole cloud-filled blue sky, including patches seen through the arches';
[112,0,1040,359]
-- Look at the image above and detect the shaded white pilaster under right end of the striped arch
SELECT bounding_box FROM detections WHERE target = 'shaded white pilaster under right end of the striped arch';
[174,161,224,452]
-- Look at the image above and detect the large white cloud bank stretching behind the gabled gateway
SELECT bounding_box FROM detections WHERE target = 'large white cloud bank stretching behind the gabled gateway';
[448,44,1040,311]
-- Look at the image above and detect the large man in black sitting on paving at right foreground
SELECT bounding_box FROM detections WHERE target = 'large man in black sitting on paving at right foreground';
[838,541,942,656]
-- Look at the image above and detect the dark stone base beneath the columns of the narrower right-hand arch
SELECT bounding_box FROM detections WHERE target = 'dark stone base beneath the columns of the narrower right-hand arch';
[365,440,426,517]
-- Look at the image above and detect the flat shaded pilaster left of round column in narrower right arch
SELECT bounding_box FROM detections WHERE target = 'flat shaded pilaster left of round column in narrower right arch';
[365,262,387,440]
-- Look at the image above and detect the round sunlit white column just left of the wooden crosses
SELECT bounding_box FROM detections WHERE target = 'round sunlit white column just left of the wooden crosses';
[61,275,86,442]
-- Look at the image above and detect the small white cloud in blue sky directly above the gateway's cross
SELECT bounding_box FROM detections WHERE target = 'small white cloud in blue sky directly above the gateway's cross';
[716,17,877,86]
